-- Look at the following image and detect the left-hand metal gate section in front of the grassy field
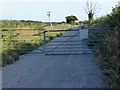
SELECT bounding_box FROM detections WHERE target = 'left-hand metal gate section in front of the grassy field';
[0,24,49,54]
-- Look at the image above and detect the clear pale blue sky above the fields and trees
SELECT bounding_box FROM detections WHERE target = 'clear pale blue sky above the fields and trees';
[0,0,119,22]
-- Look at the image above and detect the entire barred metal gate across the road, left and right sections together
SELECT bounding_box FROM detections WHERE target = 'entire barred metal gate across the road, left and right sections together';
[0,25,111,55]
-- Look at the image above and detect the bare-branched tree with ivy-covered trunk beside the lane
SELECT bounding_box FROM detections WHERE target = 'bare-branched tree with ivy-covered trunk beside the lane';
[84,1,100,22]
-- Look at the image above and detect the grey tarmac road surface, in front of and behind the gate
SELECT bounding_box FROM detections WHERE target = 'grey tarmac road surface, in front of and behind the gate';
[2,28,105,88]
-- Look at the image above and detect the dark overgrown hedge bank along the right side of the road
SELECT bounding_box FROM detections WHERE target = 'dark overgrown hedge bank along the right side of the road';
[86,7,120,88]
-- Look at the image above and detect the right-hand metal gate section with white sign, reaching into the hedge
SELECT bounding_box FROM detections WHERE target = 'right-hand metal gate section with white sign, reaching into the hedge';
[44,27,111,55]
